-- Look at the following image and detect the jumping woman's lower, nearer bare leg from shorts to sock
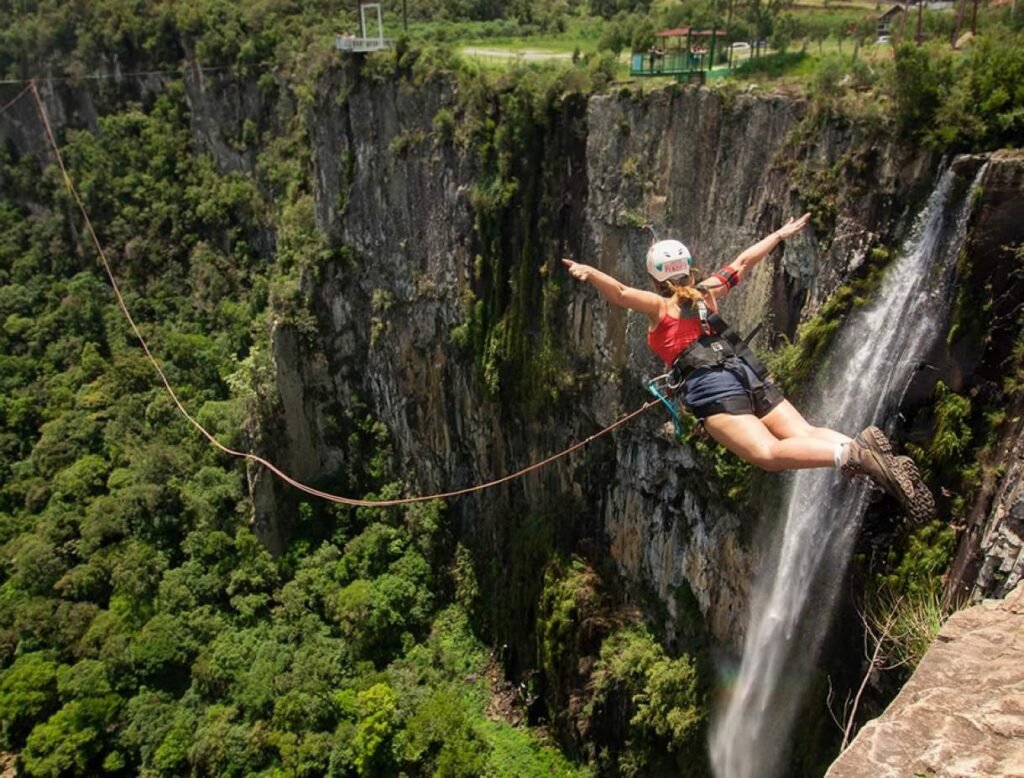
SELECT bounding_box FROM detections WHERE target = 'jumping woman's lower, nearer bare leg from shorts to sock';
[705,414,837,472]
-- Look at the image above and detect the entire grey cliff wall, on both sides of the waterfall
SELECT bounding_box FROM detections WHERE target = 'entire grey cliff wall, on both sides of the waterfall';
[5,62,1022,651]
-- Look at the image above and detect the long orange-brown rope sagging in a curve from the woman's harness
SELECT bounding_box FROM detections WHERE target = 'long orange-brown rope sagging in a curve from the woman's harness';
[28,81,658,508]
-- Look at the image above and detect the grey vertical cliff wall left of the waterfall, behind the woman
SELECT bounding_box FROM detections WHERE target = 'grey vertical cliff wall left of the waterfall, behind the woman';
[243,60,935,649]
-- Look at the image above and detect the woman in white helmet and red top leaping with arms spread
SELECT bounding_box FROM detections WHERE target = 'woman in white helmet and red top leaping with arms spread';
[562,214,934,520]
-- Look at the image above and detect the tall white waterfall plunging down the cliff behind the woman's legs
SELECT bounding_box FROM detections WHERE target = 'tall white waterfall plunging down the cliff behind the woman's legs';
[711,159,984,778]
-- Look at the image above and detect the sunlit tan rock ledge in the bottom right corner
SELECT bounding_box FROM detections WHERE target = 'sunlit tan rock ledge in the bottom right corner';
[826,585,1024,778]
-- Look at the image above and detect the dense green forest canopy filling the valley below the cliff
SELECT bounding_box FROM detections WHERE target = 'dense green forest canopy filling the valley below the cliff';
[0,78,638,776]
